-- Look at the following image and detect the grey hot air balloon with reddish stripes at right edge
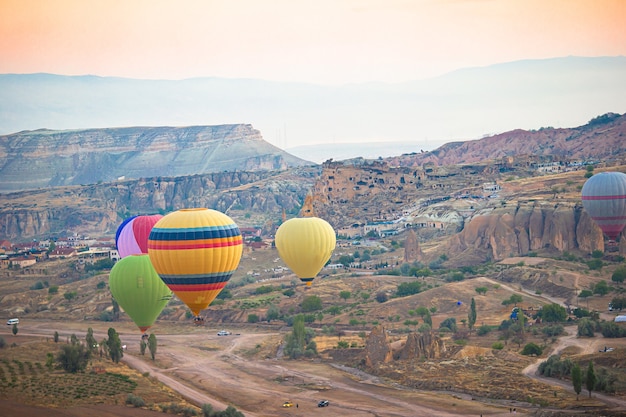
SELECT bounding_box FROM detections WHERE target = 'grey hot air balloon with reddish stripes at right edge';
[582,172,626,244]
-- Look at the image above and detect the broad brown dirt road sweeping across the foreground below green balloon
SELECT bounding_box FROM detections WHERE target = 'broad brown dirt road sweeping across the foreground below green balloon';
[21,323,512,417]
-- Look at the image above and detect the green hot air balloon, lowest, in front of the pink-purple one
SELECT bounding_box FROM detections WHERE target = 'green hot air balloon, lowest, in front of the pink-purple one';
[109,255,172,332]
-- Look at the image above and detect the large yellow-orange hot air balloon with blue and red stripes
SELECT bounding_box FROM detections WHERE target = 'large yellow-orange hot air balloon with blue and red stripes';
[148,208,243,317]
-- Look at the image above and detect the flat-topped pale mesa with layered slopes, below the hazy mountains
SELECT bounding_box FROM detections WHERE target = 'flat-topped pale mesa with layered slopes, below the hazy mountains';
[0,124,310,193]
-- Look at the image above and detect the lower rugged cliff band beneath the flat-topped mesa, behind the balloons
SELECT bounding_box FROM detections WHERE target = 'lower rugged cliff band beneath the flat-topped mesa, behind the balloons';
[0,167,318,237]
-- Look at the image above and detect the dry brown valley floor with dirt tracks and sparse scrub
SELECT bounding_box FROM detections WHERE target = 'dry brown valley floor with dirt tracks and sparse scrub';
[0,232,626,417]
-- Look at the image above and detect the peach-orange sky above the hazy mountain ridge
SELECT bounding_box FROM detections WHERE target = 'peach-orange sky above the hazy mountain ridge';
[0,0,626,85]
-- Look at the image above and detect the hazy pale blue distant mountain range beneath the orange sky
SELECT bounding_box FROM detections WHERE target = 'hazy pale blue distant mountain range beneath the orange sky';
[0,56,626,151]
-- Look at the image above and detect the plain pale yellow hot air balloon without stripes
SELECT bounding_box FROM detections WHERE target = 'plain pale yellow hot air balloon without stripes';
[276,217,336,286]
